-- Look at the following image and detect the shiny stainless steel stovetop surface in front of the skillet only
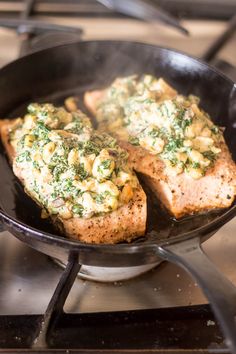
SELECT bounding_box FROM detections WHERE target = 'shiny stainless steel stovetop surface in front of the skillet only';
[0,219,236,316]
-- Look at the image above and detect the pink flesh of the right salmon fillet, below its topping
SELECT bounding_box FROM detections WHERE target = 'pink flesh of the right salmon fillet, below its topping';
[84,90,236,218]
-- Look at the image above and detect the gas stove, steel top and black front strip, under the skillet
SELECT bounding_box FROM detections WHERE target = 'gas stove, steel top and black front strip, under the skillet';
[0,2,236,353]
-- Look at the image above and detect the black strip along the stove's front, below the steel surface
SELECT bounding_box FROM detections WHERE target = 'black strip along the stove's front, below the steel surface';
[0,305,228,353]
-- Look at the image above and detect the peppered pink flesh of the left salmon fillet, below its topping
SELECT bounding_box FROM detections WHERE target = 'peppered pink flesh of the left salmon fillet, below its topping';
[0,119,147,244]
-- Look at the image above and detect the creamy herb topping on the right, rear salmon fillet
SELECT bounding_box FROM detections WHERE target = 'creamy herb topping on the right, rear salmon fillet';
[97,75,223,179]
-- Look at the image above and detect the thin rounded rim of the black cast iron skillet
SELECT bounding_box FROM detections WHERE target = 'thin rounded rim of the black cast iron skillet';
[0,40,236,254]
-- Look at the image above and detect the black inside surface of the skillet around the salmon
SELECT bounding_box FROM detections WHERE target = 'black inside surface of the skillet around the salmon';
[0,42,236,242]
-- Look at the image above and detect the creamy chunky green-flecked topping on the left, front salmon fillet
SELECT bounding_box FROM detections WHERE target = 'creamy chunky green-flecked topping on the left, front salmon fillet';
[10,104,138,219]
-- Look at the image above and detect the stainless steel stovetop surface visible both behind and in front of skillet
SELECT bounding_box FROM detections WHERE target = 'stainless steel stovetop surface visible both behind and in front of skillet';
[0,5,236,352]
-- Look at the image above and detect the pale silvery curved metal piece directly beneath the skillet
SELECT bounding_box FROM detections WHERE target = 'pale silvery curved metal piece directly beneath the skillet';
[51,258,163,283]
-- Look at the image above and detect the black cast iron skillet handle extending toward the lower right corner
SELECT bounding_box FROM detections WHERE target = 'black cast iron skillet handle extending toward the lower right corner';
[159,238,236,354]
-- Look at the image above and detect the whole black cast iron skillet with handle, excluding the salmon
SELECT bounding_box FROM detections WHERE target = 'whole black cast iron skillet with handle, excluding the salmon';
[0,41,236,353]
